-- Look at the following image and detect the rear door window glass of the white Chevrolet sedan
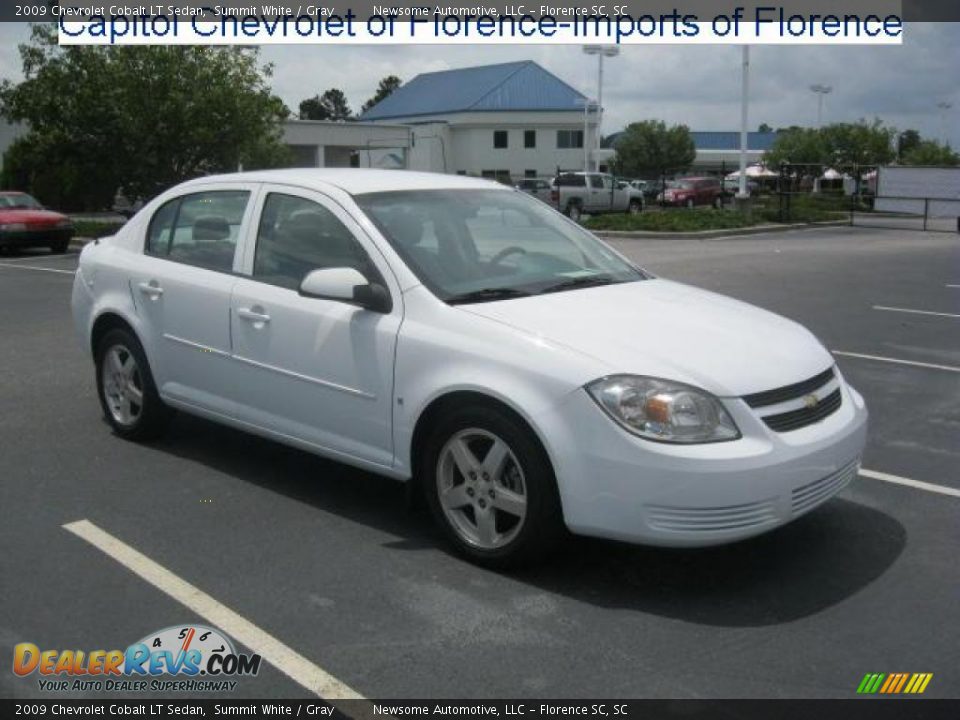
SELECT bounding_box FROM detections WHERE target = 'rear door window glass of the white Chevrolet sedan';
[146,190,250,272]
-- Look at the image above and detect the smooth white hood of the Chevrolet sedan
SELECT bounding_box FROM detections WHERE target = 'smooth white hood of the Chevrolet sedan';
[459,279,833,397]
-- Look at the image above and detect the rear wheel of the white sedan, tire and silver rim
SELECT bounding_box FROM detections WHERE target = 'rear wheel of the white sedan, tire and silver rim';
[96,328,171,440]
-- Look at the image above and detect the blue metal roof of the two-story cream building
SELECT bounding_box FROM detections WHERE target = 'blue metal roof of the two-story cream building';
[360,60,586,120]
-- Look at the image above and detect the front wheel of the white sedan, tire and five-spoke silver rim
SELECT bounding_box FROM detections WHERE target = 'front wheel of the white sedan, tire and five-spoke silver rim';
[419,406,563,568]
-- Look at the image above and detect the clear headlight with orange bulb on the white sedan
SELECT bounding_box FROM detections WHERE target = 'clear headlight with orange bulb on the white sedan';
[586,375,740,443]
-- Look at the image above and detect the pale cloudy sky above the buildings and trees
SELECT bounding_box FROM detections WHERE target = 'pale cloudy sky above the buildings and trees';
[0,23,960,148]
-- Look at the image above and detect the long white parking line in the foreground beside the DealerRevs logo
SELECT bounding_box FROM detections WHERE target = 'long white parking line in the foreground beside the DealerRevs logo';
[63,520,364,700]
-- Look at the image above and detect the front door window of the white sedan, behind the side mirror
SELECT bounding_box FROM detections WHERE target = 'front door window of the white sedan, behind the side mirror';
[253,193,375,290]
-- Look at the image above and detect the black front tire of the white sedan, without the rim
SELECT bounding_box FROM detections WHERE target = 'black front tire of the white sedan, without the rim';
[417,405,565,569]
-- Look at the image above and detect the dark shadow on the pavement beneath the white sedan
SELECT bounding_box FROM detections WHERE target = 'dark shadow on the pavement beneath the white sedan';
[154,414,907,627]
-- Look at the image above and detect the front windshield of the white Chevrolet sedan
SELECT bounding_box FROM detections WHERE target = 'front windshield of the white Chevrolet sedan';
[356,190,647,304]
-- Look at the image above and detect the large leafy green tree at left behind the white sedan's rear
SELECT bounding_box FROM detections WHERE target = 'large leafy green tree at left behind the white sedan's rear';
[0,24,288,210]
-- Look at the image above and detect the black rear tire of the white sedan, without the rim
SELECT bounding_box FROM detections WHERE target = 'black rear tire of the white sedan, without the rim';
[95,328,173,442]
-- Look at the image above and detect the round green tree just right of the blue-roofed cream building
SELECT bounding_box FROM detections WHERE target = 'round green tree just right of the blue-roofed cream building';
[613,120,697,177]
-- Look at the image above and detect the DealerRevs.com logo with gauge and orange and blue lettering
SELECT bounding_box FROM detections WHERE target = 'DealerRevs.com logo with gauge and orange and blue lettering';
[13,625,261,692]
